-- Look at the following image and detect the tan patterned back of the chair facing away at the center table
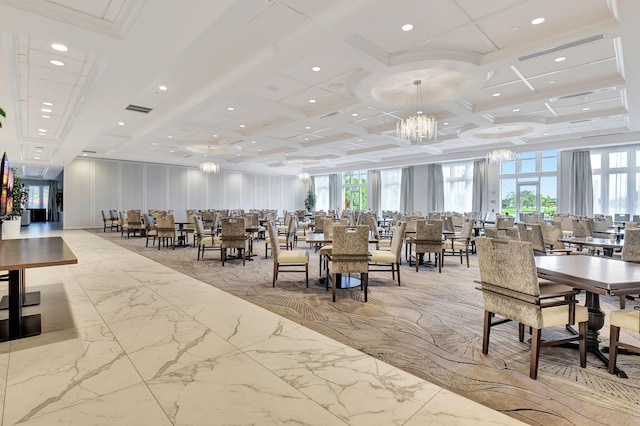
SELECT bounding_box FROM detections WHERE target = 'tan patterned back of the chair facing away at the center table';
[331,225,369,274]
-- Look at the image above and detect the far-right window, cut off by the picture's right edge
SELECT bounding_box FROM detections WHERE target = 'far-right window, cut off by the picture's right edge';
[591,145,640,215]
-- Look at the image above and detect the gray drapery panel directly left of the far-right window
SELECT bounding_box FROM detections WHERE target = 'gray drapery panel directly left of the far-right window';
[569,151,593,217]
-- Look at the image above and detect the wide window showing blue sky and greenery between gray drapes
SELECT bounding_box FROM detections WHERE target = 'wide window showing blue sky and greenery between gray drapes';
[500,151,558,217]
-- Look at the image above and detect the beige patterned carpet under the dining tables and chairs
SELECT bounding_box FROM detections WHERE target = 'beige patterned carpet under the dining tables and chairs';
[90,229,640,425]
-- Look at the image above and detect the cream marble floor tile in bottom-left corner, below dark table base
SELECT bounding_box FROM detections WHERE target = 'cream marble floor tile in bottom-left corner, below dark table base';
[3,325,142,425]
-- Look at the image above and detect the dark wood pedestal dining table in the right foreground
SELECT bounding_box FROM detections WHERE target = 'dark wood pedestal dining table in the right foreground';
[535,256,640,378]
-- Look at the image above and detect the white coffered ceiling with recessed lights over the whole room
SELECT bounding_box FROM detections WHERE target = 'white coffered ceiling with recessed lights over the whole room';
[0,0,640,179]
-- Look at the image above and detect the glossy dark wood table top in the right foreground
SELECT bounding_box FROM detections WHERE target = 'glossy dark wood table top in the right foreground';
[535,255,640,295]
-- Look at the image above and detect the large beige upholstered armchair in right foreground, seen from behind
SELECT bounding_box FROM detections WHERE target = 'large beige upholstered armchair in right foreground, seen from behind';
[476,237,589,379]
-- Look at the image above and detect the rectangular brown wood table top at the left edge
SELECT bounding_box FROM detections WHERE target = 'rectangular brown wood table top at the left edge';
[0,237,78,271]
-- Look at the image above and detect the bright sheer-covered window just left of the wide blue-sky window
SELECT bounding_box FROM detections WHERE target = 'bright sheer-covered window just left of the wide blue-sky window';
[442,162,473,213]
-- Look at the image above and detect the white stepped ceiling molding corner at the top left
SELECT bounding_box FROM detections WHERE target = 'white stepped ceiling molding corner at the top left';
[0,0,145,39]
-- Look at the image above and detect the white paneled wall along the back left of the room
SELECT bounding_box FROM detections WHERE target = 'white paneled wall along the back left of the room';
[64,158,305,229]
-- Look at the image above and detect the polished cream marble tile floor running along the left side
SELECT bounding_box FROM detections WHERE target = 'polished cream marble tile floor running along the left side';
[0,227,519,426]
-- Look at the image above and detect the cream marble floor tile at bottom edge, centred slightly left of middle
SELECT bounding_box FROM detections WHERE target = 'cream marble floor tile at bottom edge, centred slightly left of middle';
[148,351,348,425]
